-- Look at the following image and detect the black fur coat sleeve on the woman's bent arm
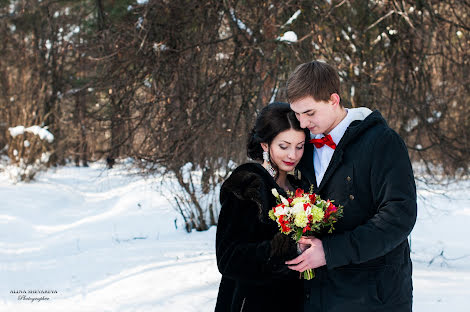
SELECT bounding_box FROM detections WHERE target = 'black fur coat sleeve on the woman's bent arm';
[216,189,298,282]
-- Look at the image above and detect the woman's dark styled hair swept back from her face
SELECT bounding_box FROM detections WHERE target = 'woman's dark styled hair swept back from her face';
[246,102,308,163]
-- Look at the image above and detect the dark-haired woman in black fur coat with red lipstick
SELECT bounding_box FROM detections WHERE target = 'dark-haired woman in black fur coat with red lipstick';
[215,103,308,312]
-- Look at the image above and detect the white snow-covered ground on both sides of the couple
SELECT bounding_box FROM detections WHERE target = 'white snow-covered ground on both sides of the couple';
[0,163,470,312]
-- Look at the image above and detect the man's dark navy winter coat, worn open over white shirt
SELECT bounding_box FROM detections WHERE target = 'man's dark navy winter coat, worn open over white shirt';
[298,111,416,312]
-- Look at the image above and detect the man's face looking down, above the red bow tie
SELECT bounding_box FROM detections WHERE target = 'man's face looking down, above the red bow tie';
[290,95,342,135]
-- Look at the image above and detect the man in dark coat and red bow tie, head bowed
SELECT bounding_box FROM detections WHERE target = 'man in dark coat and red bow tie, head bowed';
[286,61,416,312]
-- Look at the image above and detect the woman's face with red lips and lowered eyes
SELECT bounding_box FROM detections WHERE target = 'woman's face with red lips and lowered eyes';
[261,129,305,172]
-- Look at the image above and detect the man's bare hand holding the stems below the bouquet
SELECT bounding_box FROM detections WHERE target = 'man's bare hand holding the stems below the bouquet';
[286,236,326,272]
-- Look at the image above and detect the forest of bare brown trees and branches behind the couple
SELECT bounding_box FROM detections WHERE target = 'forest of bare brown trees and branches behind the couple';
[0,0,470,231]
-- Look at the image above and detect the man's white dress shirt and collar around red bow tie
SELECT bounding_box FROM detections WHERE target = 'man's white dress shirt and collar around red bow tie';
[310,107,372,187]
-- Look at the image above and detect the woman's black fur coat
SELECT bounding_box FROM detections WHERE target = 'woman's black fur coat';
[215,163,309,312]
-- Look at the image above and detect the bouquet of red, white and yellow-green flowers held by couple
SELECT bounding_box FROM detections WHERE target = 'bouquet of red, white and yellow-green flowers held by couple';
[269,188,343,280]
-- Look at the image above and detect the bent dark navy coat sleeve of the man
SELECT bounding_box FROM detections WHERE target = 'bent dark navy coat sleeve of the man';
[322,129,417,269]
